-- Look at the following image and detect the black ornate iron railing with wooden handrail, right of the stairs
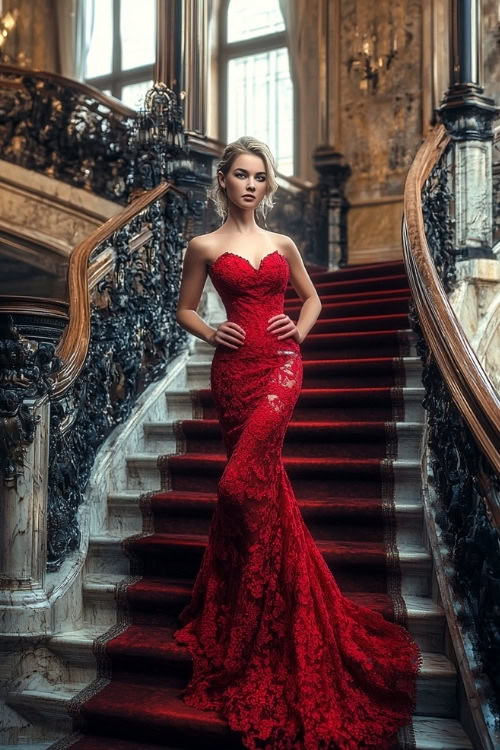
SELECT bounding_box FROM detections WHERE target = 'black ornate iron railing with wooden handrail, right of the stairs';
[403,125,500,736]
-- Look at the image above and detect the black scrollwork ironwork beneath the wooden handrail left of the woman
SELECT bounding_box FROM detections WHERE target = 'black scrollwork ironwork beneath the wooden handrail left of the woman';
[48,193,187,571]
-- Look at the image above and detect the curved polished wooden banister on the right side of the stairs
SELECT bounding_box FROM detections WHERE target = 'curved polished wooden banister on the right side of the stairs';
[403,124,500,488]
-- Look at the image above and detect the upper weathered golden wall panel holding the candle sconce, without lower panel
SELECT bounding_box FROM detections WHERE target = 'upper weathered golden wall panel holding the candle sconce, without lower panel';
[338,0,423,199]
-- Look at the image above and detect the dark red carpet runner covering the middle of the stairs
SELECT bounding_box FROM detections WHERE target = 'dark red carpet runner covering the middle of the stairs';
[52,261,410,750]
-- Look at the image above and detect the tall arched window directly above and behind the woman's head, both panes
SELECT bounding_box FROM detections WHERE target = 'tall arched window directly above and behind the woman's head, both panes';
[219,0,295,175]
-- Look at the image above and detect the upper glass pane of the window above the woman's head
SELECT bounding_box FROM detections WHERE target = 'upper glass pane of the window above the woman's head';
[227,0,285,42]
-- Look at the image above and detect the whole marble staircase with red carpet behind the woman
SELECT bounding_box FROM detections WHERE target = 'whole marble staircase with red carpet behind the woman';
[3,262,472,750]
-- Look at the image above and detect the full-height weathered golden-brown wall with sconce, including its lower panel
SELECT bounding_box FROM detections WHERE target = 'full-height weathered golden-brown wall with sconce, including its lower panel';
[329,0,431,263]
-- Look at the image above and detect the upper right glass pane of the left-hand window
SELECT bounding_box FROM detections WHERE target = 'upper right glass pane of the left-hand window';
[120,0,156,70]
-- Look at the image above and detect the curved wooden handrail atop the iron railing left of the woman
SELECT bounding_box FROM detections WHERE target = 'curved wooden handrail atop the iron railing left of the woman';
[53,182,187,397]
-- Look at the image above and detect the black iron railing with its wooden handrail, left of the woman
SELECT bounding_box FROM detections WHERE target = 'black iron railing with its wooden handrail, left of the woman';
[48,184,187,570]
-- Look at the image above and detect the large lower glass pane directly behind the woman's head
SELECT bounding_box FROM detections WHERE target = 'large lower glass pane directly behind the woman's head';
[227,47,293,175]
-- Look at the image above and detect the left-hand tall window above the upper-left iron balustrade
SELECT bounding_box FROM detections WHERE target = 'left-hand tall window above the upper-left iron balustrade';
[85,0,156,109]
